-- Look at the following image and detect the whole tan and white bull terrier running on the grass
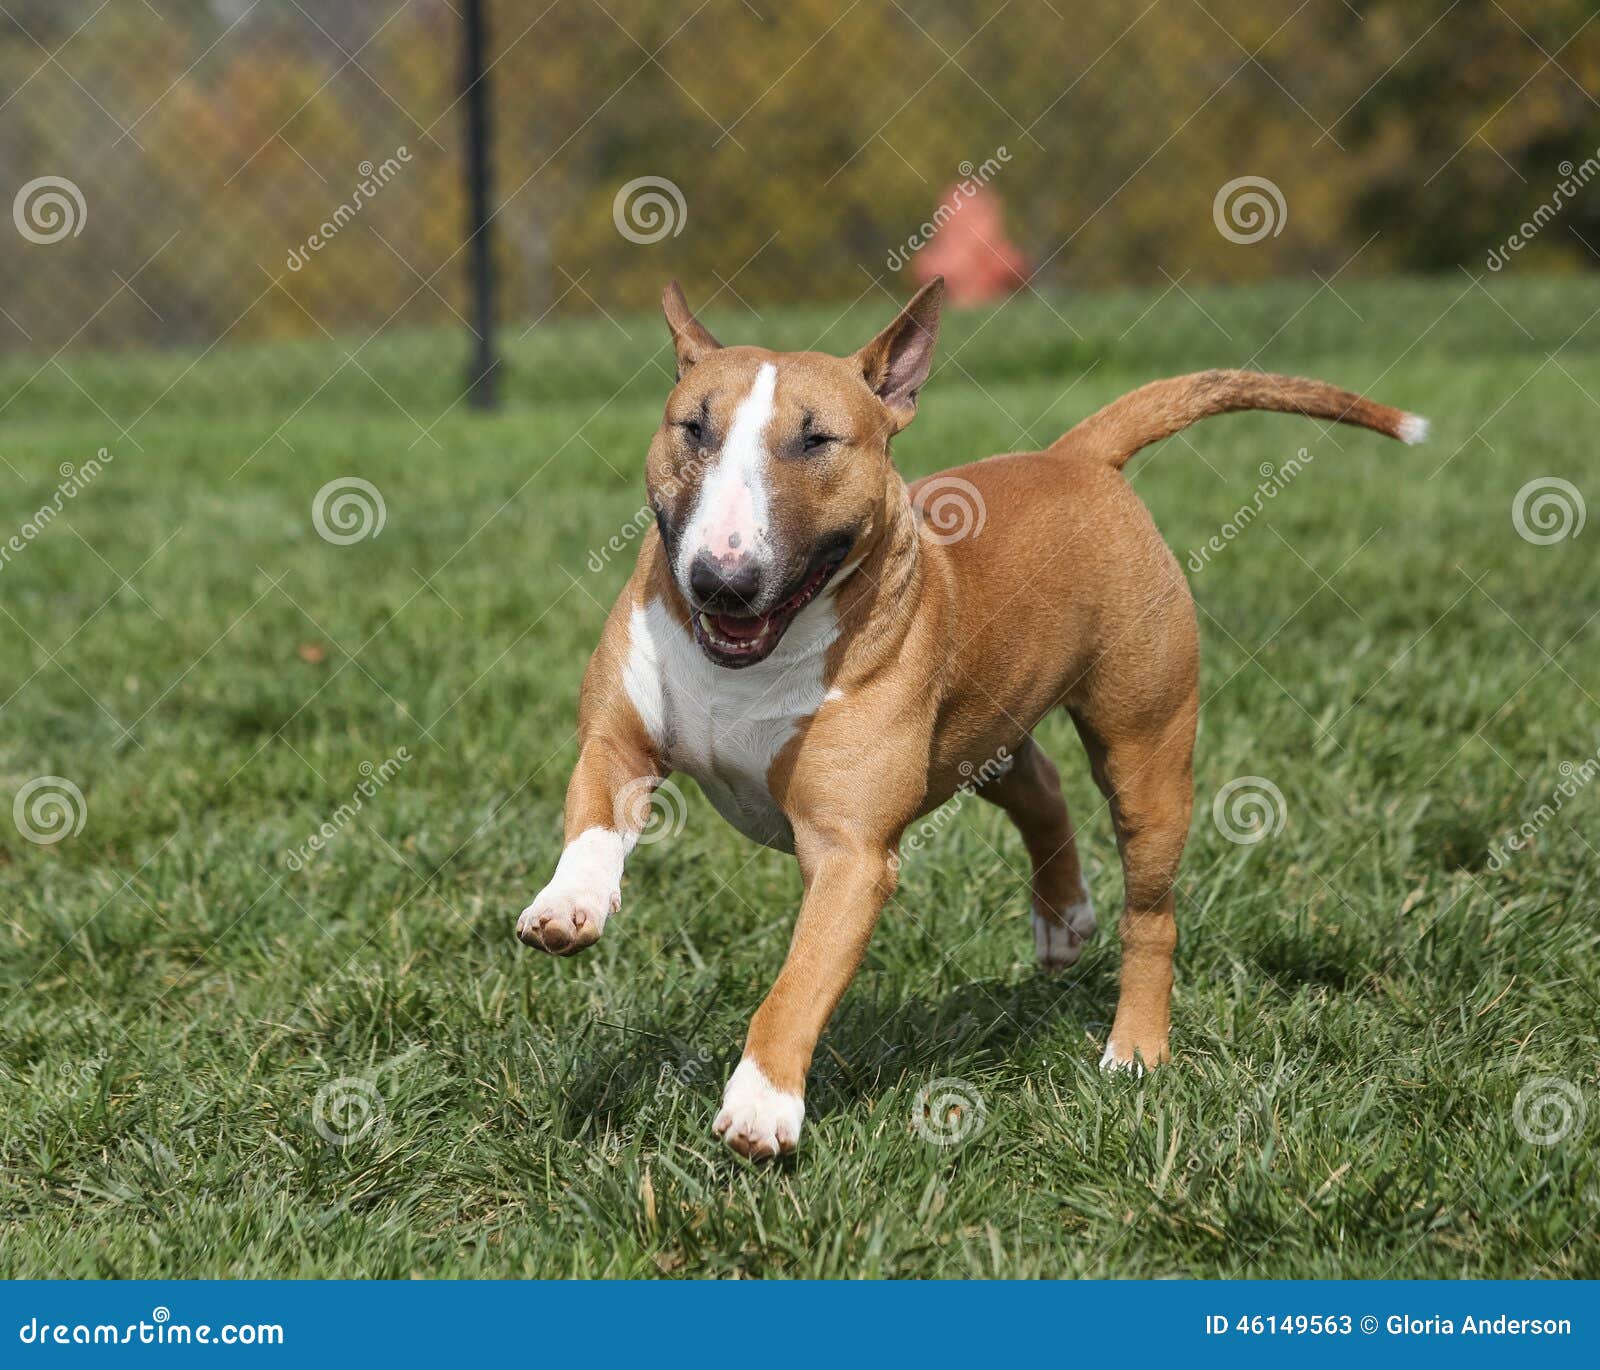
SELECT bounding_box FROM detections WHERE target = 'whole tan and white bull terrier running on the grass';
[517,280,1427,1157]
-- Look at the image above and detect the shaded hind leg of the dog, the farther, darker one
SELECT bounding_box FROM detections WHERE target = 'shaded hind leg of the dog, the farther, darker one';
[978,736,1094,970]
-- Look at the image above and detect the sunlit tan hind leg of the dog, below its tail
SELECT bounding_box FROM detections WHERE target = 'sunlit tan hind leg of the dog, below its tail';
[1077,690,1198,1069]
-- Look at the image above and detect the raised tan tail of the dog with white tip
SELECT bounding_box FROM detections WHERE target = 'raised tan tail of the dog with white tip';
[1053,371,1427,467]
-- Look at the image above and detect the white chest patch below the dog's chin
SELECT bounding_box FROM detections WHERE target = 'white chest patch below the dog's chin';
[622,595,838,851]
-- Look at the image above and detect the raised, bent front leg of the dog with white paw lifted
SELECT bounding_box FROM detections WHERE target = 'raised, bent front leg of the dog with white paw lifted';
[517,719,666,955]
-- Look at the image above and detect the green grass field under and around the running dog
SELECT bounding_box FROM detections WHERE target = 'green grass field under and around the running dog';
[0,275,1600,1277]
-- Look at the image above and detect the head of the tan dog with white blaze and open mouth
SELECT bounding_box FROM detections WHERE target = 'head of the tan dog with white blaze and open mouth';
[645,280,944,667]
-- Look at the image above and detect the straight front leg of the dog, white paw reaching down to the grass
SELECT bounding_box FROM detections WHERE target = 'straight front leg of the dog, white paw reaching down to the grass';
[715,831,898,1157]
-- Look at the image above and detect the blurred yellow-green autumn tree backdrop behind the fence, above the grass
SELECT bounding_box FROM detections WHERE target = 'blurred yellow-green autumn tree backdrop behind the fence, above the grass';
[0,0,1600,400]
